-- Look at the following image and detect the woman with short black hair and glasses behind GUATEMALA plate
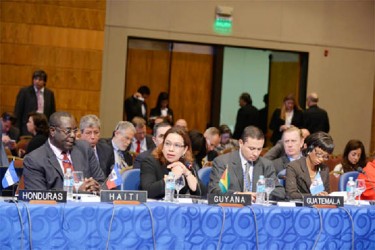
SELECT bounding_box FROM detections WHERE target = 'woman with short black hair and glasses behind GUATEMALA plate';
[285,132,335,200]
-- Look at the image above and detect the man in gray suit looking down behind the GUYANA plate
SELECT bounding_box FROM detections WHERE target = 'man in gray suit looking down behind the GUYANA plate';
[208,126,285,200]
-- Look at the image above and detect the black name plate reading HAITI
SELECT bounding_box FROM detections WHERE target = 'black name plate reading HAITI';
[100,190,147,203]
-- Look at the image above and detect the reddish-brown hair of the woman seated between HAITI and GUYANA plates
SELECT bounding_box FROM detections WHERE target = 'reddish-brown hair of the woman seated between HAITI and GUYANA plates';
[152,127,193,164]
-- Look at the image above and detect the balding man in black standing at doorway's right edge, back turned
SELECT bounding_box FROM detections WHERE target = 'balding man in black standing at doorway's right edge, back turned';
[303,93,329,134]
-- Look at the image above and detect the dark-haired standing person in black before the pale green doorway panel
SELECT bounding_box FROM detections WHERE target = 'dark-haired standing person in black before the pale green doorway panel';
[233,93,260,139]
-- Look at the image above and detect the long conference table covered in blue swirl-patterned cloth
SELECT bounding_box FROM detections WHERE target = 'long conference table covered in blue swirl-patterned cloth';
[0,198,375,249]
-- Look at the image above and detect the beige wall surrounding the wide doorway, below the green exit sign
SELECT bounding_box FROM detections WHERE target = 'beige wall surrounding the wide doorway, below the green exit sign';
[100,0,375,153]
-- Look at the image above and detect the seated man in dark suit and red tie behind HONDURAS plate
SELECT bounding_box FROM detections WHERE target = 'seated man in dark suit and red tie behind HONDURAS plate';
[23,112,105,192]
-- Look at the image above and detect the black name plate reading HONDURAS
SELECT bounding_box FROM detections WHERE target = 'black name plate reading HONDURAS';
[18,190,66,202]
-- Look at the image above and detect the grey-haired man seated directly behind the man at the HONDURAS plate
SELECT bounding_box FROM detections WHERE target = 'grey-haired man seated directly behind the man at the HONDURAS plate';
[79,115,114,178]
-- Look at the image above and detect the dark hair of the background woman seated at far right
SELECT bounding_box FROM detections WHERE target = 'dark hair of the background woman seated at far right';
[342,140,366,173]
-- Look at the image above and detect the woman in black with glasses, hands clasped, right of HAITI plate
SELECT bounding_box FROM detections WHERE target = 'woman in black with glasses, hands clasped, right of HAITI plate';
[141,127,202,199]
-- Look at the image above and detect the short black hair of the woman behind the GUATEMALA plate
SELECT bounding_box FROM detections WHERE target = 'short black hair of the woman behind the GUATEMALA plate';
[304,131,335,155]
